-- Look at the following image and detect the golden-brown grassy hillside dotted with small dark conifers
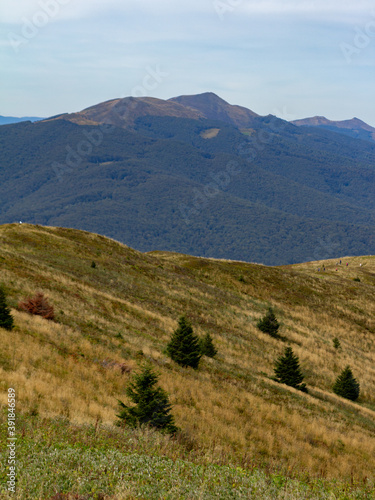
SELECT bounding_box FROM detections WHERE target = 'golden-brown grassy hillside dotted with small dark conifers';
[0,224,375,498]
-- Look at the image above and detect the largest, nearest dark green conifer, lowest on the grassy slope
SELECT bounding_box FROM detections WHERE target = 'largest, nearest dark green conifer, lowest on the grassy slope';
[116,366,178,434]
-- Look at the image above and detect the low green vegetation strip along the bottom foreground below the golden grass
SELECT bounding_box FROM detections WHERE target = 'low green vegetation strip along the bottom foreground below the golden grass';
[0,415,373,500]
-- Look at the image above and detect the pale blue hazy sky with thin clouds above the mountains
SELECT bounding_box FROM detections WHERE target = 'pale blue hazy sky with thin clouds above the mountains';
[0,0,375,126]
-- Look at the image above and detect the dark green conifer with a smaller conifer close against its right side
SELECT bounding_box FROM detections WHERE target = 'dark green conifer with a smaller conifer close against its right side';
[166,316,202,369]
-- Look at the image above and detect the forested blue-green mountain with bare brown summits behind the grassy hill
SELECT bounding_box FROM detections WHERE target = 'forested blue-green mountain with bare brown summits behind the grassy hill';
[0,93,375,264]
